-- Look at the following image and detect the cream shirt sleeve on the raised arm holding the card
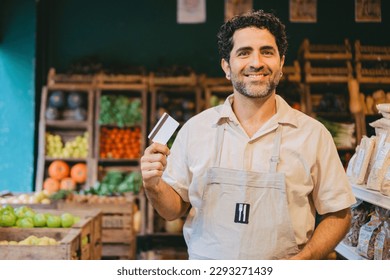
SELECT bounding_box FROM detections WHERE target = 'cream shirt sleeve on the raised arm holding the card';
[162,124,192,202]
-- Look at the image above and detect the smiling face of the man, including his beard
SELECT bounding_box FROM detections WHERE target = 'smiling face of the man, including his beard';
[221,27,284,98]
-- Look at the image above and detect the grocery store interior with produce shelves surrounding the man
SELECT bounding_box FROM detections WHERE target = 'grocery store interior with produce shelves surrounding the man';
[0,0,390,260]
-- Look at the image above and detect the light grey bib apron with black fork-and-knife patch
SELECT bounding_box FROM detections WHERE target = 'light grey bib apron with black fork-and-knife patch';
[188,124,299,259]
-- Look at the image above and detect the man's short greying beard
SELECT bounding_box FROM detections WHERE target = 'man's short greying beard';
[231,67,281,99]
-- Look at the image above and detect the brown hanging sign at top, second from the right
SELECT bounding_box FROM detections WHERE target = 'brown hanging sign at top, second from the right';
[290,0,317,22]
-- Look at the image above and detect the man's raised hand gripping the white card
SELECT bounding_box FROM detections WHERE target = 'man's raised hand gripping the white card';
[141,143,170,189]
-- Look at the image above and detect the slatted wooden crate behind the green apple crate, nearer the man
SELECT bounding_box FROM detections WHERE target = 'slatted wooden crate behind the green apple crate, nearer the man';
[58,194,136,259]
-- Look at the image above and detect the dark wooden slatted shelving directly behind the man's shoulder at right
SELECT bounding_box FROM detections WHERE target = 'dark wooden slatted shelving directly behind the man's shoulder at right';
[299,39,362,165]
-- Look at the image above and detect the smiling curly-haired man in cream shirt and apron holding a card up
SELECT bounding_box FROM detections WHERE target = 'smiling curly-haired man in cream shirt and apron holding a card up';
[141,10,355,259]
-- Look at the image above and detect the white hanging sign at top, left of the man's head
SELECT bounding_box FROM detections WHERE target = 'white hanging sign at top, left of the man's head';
[177,0,206,23]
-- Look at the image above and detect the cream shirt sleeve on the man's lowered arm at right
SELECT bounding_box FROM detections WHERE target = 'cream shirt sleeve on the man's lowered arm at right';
[313,128,356,215]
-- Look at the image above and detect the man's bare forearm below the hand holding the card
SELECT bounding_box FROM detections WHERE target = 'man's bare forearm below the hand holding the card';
[145,179,189,220]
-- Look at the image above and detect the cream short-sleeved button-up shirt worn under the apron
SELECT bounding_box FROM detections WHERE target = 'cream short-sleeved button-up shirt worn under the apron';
[163,95,355,245]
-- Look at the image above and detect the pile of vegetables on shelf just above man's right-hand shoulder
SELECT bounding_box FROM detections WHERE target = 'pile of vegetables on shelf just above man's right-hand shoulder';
[317,118,356,148]
